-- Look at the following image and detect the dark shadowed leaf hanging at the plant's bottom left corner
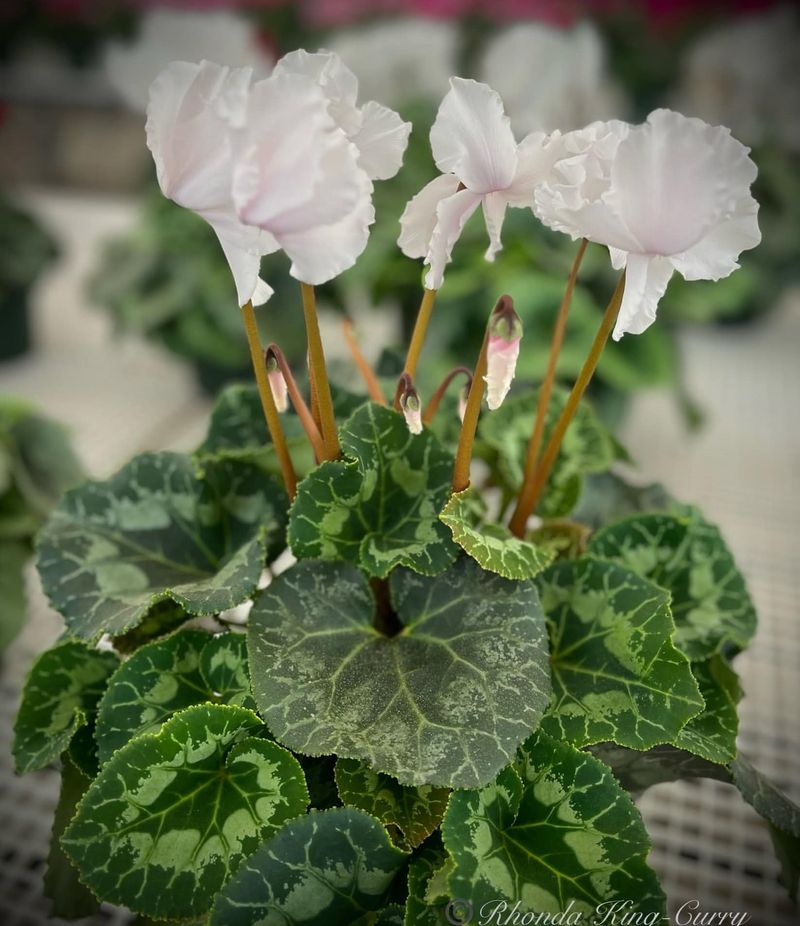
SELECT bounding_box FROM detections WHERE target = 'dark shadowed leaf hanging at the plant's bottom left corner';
[44,753,100,920]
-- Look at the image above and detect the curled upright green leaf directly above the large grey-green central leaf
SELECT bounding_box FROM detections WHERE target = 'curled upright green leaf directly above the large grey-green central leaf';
[289,404,458,577]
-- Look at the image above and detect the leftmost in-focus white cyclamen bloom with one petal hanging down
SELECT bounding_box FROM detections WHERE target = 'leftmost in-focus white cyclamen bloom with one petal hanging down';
[146,61,272,305]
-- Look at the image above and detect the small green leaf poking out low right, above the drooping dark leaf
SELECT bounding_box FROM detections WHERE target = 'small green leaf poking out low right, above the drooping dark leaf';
[673,656,742,765]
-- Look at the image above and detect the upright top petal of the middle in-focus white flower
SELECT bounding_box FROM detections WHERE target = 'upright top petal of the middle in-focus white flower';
[431,77,517,194]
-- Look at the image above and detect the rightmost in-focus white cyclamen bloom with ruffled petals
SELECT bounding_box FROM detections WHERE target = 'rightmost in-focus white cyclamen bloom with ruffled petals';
[534,109,761,340]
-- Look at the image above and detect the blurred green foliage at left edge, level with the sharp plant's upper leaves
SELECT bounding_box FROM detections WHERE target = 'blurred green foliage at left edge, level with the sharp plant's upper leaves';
[0,396,83,652]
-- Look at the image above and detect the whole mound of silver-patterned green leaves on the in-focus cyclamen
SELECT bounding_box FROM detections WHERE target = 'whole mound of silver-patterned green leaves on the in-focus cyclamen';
[14,387,800,926]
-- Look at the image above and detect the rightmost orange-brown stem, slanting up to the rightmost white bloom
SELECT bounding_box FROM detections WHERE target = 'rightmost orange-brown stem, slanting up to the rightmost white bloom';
[509,272,625,537]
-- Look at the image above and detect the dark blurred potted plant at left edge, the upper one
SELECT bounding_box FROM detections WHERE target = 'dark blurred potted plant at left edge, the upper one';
[0,195,57,360]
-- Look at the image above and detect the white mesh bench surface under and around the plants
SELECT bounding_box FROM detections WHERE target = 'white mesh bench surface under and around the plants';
[0,195,800,926]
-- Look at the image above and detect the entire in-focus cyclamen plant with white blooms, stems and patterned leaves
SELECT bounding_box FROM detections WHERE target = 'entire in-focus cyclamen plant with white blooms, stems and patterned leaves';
[14,51,800,926]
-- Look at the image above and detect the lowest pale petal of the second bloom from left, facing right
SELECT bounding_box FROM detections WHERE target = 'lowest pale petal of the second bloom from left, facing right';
[279,190,375,286]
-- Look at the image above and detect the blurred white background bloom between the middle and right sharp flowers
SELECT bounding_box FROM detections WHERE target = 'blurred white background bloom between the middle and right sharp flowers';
[481,22,627,133]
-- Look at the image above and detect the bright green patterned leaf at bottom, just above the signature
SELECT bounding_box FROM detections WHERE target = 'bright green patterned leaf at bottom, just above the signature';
[442,733,665,918]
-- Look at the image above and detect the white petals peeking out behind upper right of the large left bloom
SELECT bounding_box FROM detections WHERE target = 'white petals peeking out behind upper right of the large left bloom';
[274,48,411,180]
